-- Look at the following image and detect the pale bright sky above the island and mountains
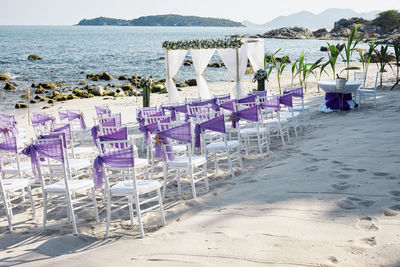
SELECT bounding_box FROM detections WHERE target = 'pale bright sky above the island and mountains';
[0,0,400,25]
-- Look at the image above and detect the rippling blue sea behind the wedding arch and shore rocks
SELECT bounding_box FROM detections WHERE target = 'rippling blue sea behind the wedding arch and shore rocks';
[0,26,368,109]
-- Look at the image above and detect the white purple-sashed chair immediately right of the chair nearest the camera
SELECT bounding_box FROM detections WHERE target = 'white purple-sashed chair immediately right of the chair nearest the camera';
[155,122,209,199]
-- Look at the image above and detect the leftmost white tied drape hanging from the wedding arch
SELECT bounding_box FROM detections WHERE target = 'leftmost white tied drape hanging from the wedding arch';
[165,50,187,103]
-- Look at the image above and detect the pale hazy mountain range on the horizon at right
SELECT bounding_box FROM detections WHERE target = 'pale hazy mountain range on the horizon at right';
[264,8,380,30]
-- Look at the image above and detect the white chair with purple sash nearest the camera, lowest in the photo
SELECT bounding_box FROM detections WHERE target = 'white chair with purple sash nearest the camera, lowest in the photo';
[99,140,165,238]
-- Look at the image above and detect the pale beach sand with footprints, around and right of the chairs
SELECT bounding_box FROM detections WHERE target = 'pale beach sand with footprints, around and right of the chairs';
[0,65,400,266]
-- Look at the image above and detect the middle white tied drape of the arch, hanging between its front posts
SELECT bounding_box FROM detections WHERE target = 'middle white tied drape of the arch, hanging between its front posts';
[190,49,215,99]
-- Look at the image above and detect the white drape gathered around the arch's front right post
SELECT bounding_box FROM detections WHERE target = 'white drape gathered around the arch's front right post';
[218,45,247,98]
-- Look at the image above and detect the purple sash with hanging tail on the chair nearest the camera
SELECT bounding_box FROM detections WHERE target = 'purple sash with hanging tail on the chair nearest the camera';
[93,146,135,190]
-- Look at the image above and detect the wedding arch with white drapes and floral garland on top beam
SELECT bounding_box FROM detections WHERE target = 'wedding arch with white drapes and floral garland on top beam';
[162,38,264,103]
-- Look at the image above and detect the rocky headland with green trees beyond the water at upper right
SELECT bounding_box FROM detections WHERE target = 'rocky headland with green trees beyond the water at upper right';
[232,18,400,44]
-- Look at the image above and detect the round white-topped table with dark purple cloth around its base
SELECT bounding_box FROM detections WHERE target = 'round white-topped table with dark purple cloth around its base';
[318,80,361,112]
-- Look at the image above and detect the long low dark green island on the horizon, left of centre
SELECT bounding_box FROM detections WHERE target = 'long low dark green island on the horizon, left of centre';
[77,15,245,27]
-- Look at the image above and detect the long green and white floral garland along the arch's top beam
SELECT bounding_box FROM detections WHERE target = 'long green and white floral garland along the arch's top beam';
[162,38,243,50]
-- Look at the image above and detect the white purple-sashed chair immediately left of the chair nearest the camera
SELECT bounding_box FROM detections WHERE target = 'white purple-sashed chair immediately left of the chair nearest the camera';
[24,136,99,235]
